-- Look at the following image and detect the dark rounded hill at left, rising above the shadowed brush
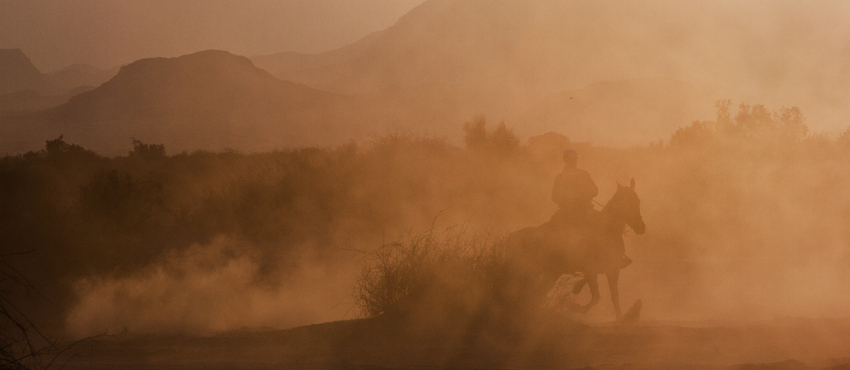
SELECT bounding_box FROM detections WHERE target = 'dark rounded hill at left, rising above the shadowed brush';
[5,51,360,155]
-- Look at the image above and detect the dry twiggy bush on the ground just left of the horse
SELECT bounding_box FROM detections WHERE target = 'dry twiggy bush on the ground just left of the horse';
[354,224,506,317]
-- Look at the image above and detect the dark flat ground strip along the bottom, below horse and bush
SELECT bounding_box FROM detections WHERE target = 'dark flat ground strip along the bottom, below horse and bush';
[64,317,850,369]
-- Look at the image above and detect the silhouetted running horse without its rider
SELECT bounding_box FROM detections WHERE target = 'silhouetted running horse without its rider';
[506,179,646,321]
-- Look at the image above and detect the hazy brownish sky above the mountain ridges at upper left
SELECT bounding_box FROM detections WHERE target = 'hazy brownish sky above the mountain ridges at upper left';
[0,0,424,72]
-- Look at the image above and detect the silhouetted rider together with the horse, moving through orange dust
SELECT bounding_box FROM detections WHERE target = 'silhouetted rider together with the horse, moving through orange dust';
[506,150,646,321]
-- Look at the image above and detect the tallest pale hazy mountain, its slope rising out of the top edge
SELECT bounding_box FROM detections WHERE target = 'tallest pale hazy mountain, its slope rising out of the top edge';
[252,0,850,139]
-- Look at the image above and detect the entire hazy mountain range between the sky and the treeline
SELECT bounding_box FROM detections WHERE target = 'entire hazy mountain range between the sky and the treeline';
[8,0,850,153]
